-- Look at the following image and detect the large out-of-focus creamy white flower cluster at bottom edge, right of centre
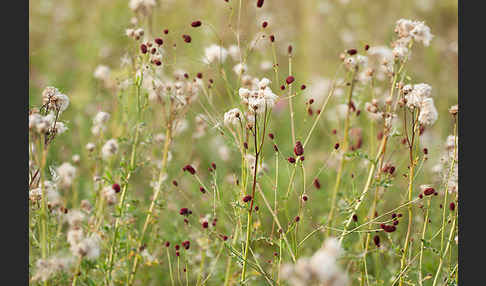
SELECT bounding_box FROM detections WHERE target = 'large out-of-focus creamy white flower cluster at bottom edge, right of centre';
[281,238,349,286]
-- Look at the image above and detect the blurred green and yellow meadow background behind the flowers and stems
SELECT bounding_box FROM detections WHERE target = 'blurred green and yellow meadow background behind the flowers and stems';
[29,0,458,285]
